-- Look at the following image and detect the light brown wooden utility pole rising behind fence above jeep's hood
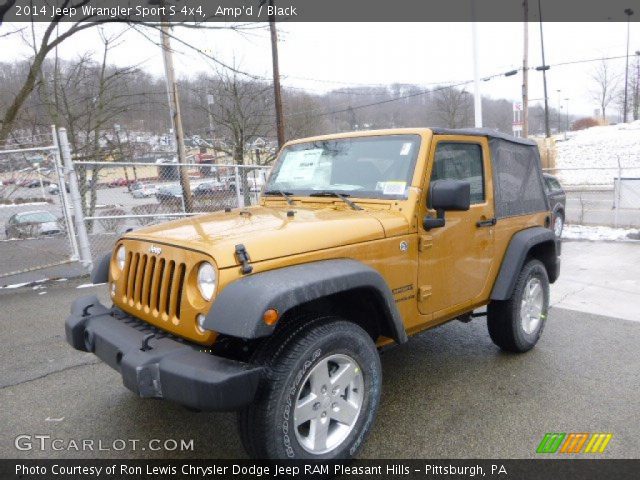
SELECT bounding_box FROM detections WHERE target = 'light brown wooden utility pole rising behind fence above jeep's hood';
[160,11,193,212]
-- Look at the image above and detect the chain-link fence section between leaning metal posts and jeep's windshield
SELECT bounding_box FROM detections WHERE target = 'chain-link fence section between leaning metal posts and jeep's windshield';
[74,161,270,261]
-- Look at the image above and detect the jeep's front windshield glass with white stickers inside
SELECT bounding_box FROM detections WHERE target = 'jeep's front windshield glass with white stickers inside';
[265,135,420,198]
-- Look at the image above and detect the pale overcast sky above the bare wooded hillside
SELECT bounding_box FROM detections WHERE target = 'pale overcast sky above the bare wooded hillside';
[0,23,640,120]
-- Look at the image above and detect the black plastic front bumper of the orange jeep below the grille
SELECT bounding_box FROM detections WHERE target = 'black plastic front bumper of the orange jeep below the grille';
[65,295,262,410]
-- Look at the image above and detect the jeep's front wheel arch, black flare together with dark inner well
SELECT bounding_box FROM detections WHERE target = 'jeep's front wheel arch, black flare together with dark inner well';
[203,259,407,343]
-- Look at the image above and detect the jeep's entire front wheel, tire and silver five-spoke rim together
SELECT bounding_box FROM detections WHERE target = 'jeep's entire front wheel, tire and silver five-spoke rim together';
[238,317,382,460]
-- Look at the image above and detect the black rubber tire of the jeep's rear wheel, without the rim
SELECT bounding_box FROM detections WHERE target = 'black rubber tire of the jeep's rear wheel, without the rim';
[487,259,549,353]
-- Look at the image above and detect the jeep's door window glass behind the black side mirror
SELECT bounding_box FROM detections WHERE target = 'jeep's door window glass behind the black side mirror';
[431,142,485,204]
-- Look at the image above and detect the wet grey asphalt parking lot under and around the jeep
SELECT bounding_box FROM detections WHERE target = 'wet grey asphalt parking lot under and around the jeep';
[0,268,640,458]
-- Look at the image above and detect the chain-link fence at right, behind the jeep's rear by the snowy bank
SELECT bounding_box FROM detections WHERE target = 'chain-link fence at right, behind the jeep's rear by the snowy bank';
[545,166,640,227]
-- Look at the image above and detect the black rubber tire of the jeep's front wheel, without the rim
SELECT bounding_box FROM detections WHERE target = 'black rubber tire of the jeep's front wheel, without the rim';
[238,316,382,460]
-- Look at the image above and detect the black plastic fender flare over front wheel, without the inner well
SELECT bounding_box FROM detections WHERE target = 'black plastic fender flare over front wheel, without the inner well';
[203,259,407,343]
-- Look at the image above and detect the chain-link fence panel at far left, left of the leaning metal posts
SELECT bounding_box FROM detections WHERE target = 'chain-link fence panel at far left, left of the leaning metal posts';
[0,130,77,279]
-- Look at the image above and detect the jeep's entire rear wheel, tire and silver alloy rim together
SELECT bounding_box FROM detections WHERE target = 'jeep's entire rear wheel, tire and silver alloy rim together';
[487,259,549,353]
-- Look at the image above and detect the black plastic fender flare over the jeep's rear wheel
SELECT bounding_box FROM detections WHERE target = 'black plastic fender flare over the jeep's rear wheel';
[491,227,560,300]
